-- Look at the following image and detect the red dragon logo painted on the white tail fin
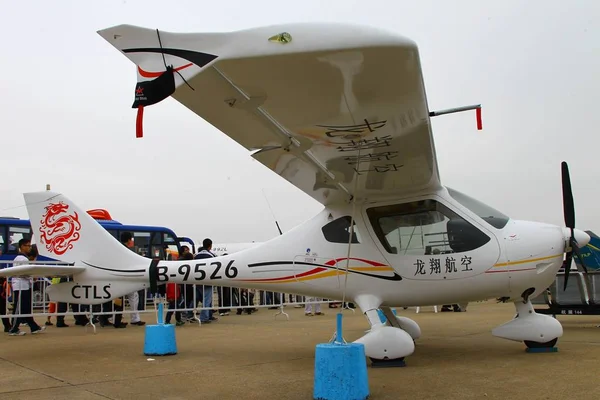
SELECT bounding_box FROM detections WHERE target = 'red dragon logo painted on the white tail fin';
[40,201,81,255]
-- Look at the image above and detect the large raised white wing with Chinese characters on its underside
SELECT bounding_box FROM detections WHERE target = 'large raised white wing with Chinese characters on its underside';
[98,24,440,205]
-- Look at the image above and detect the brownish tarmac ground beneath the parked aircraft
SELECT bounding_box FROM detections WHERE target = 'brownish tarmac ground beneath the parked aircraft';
[0,301,600,400]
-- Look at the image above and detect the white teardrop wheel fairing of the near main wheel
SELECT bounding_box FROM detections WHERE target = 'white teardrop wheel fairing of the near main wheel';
[354,326,415,360]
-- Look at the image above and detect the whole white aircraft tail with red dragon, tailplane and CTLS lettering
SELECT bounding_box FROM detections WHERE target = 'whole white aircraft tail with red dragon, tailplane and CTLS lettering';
[0,191,152,304]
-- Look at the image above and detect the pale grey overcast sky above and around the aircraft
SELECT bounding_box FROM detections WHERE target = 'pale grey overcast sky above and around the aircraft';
[0,0,600,242]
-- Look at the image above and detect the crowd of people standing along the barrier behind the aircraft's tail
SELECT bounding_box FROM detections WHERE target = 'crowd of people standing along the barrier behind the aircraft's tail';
[0,236,338,336]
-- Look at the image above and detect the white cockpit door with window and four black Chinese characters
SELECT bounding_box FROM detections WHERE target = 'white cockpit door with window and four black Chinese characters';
[362,195,501,280]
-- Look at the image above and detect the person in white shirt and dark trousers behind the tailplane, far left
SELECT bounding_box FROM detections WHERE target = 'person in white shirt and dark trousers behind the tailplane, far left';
[8,239,46,336]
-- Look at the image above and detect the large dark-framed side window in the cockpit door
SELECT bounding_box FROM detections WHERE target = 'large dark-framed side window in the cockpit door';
[367,200,490,255]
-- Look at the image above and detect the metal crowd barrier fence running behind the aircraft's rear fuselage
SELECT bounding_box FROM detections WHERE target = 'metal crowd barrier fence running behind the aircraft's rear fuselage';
[0,261,352,331]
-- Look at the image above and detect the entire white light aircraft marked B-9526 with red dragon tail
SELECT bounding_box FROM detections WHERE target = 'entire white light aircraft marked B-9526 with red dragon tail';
[0,24,589,365]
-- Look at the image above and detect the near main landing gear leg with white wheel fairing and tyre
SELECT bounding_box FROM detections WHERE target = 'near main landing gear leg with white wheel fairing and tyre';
[354,295,415,368]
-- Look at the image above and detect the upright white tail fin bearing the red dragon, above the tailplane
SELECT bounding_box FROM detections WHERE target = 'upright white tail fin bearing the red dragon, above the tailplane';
[23,191,148,270]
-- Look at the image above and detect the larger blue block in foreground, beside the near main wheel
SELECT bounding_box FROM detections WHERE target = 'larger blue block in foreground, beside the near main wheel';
[313,343,369,400]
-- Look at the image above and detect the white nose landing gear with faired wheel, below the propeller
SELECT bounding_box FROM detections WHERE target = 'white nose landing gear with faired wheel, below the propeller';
[492,295,563,349]
